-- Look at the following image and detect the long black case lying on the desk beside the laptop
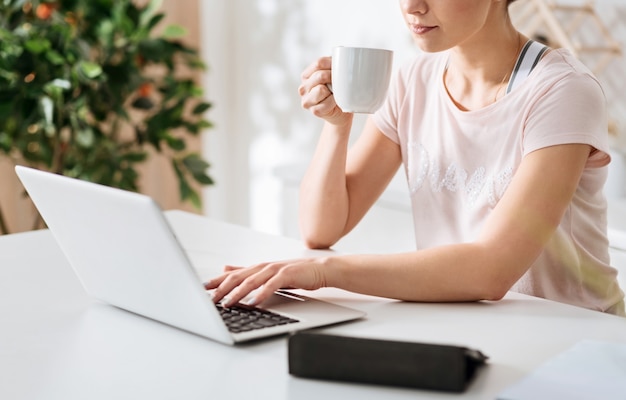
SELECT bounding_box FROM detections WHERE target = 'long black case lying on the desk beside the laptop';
[288,332,487,392]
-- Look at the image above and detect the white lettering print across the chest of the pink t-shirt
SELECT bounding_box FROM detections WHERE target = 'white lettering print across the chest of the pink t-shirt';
[407,142,513,207]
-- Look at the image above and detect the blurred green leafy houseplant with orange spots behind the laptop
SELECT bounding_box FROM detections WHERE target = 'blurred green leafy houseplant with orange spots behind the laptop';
[0,0,213,232]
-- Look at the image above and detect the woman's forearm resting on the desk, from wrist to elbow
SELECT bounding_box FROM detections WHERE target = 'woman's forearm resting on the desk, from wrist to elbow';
[324,243,530,302]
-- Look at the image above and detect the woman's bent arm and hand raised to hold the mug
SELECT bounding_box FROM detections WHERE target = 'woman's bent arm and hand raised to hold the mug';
[299,57,401,248]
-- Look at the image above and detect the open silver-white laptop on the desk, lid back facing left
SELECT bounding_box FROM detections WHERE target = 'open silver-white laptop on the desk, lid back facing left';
[16,166,365,344]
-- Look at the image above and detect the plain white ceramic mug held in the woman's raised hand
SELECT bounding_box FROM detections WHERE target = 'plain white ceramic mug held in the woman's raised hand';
[331,46,393,113]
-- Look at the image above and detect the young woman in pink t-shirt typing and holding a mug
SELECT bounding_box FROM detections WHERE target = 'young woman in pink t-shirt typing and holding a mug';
[206,0,624,315]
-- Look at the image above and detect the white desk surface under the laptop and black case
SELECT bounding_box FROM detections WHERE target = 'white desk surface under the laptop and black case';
[0,212,626,400]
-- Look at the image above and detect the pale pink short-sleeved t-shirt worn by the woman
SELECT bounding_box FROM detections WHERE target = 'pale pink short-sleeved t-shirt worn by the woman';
[374,50,624,314]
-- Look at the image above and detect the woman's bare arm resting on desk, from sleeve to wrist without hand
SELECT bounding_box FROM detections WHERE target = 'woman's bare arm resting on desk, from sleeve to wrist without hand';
[316,144,591,301]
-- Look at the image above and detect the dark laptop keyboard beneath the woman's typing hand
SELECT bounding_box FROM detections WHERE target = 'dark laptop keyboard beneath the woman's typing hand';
[216,304,298,333]
